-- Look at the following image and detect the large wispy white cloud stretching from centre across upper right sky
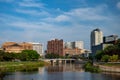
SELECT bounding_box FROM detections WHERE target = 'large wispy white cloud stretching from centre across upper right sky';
[42,5,111,24]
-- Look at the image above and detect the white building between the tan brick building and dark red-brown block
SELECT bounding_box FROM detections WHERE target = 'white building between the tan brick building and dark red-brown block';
[30,42,43,56]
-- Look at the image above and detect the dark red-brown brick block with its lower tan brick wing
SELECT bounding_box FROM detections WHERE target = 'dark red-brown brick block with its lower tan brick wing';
[46,39,84,56]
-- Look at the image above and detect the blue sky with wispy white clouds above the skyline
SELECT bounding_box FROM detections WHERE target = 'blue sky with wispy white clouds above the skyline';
[0,0,120,49]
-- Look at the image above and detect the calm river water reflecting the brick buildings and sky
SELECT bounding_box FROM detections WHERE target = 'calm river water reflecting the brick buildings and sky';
[0,64,120,80]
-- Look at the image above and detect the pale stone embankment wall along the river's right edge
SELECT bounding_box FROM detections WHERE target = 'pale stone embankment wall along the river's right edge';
[99,65,120,73]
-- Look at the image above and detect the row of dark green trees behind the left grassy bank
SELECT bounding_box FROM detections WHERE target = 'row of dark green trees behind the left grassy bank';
[0,50,40,61]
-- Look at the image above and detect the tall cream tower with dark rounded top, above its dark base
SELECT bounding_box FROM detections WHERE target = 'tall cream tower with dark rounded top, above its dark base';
[91,28,103,46]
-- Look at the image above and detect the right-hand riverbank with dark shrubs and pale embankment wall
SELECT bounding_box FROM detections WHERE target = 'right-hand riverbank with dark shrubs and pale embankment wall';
[84,62,120,73]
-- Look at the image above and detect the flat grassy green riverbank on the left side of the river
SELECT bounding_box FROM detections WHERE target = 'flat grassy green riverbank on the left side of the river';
[0,61,48,72]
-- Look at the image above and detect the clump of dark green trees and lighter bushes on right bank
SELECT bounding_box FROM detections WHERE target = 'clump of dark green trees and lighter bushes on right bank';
[95,39,120,61]
